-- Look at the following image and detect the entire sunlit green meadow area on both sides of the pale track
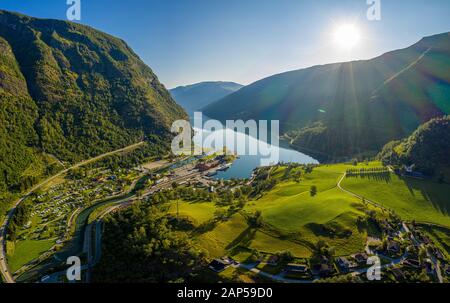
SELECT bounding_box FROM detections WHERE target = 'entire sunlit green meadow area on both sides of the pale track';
[169,162,450,260]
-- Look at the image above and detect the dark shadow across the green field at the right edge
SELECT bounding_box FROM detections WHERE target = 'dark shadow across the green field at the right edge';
[401,177,450,216]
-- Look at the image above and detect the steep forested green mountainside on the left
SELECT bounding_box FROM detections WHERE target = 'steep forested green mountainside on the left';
[0,10,186,192]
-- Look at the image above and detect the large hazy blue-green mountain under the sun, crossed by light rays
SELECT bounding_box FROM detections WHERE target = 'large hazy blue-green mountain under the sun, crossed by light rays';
[203,33,450,160]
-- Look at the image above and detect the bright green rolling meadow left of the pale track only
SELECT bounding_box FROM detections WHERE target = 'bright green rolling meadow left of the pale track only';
[183,163,386,259]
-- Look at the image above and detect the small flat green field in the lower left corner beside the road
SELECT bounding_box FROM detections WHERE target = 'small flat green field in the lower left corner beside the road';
[8,239,55,272]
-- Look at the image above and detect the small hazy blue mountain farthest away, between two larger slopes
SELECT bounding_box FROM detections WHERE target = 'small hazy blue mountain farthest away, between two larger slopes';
[170,81,243,112]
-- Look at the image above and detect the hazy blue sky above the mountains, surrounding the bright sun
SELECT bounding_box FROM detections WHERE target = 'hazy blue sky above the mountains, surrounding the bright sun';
[0,0,450,88]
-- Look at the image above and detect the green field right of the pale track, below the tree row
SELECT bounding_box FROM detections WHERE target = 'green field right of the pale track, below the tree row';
[342,174,450,227]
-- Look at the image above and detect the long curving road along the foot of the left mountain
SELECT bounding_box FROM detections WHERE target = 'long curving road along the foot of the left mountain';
[0,141,144,283]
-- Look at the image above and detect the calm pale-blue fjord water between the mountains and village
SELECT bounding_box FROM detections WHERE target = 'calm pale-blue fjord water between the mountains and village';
[193,119,319,180]
